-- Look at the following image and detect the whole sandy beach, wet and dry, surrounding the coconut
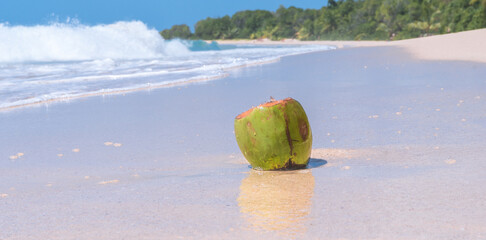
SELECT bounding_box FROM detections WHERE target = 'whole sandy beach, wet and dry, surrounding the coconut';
[0,29,486,239]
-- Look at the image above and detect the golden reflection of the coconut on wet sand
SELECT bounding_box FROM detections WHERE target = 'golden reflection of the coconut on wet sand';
[238,170,314,235]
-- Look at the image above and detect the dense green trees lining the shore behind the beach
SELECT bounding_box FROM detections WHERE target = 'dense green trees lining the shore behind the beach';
[160,0,486,40]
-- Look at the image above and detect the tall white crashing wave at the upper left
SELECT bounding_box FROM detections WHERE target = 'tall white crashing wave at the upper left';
[0,21,189,62]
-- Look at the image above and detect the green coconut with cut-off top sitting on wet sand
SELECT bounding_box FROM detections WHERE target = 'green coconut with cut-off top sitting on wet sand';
[235,98,312,170]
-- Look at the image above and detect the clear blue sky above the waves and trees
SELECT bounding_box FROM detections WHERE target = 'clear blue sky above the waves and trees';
[0,0,327,30]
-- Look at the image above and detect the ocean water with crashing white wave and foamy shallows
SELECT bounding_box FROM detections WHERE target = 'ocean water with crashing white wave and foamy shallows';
[0,21,333,110]
